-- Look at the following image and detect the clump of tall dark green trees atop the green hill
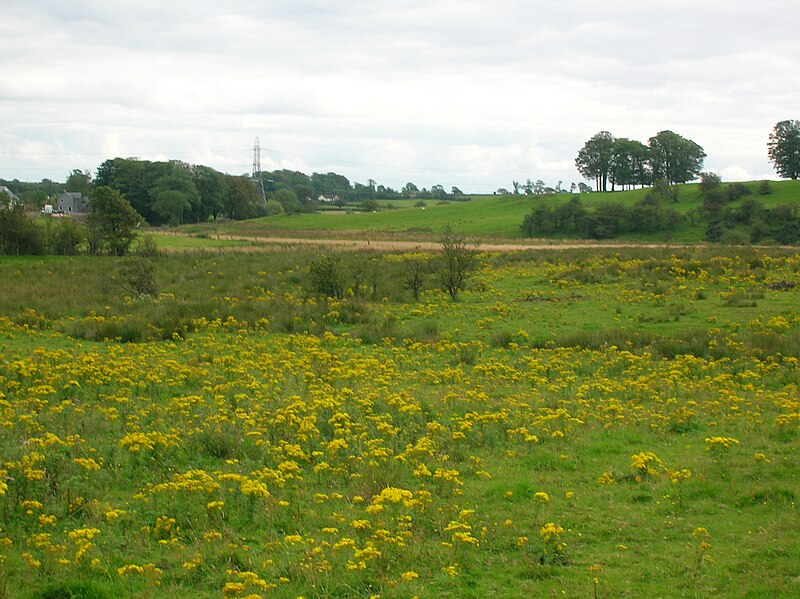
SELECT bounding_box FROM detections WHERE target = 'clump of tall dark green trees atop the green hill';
[575,130,706,191]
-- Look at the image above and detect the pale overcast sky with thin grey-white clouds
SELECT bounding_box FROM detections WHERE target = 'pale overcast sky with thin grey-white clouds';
[0,0,800,193]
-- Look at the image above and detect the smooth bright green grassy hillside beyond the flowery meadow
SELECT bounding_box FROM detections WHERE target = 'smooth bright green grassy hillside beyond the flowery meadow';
[184,181,800,243]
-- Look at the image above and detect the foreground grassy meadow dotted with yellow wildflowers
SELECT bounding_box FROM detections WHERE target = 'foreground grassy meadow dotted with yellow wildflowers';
[0,246,800,599]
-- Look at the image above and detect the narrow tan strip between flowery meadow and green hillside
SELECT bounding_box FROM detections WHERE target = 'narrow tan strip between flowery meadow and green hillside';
[152,231,703,252]
